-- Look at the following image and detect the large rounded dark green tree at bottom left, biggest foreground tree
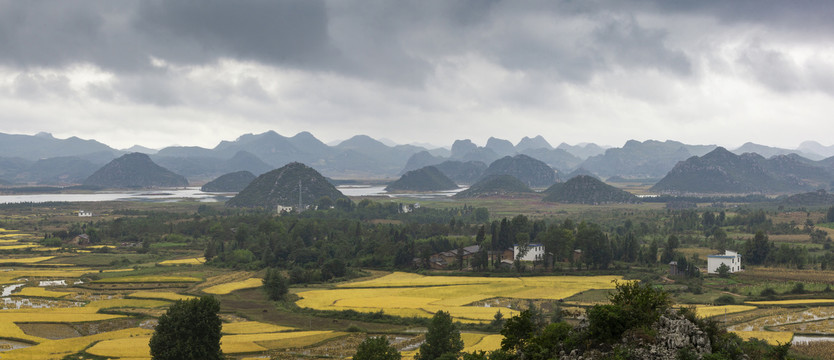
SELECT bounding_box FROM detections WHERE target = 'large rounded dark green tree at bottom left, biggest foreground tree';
[150,296,223,360]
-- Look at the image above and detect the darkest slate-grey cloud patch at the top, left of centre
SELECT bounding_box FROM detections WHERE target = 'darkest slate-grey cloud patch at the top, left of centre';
[133,0,338,68]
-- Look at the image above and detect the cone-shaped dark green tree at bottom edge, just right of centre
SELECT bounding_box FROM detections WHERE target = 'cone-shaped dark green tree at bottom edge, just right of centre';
[414,310,463,360]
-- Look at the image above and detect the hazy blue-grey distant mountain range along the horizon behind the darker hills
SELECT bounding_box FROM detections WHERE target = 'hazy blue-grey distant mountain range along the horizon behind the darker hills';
[0,131,834,193]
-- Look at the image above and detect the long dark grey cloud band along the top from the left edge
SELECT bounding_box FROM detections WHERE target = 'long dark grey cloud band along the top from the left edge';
[0,0,689,84]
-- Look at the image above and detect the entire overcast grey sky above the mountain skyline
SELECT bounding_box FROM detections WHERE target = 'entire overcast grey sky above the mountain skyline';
[0,0,834,148]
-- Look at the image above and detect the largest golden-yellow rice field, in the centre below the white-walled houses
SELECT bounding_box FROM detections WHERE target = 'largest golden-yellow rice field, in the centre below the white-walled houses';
[296,272,622,322]
